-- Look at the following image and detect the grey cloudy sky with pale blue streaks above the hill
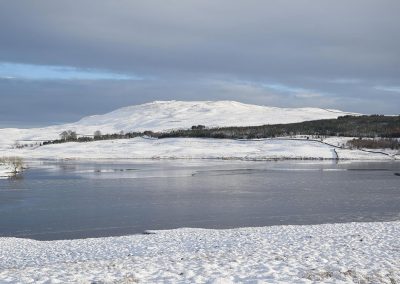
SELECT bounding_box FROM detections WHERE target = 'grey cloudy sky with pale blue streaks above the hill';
[0,0,400,127]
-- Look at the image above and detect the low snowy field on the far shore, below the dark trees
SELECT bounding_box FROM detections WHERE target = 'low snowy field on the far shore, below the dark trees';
[0,137,394,160]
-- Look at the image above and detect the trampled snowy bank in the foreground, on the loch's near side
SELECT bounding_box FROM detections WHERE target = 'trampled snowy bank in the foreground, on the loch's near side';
[0,222,400,283]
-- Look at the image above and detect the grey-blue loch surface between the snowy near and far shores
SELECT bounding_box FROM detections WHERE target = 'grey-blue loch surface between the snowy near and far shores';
[0,160,400,240]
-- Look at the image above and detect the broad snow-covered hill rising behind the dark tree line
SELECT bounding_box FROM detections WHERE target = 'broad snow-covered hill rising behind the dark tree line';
[0,101,353,149]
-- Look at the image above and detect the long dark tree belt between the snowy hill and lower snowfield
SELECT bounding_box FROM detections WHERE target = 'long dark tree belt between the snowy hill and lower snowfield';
[43,115,400,148]
